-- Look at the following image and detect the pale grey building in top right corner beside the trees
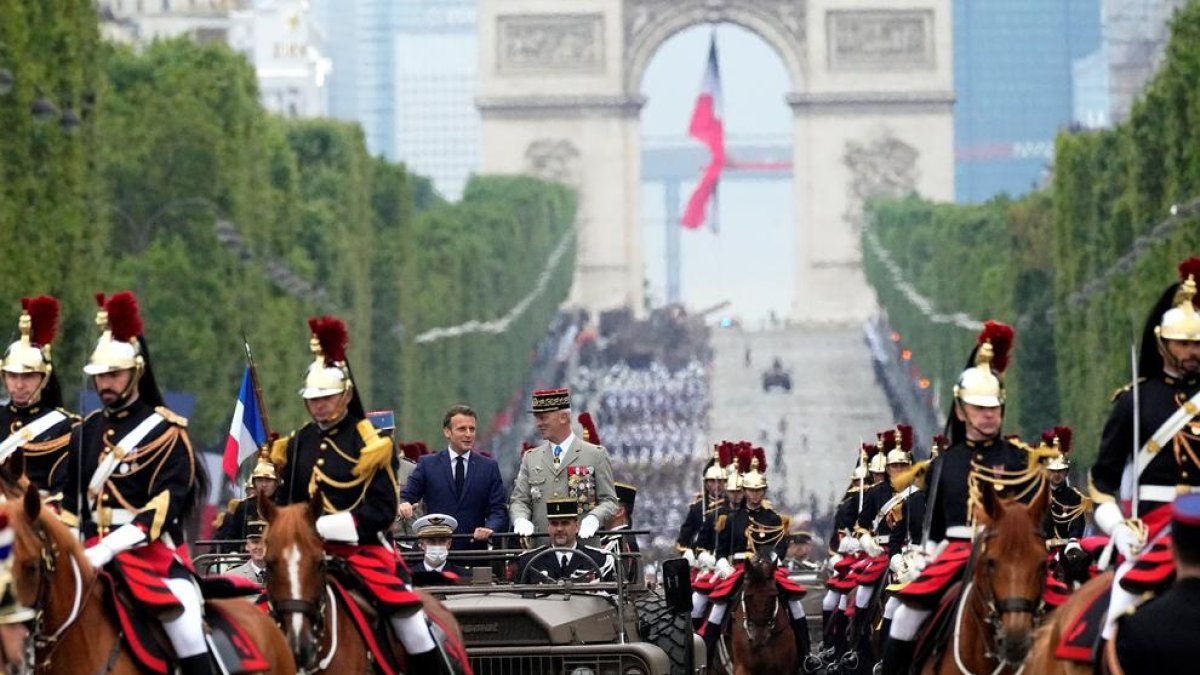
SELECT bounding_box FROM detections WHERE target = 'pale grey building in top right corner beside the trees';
[1100,0,1184,123]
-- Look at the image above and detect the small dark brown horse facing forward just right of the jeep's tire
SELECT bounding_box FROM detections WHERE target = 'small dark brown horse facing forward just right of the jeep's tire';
[730,555,799,675]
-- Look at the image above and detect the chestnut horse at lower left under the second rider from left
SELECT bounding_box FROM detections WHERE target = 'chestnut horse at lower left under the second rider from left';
[4,485,295,675]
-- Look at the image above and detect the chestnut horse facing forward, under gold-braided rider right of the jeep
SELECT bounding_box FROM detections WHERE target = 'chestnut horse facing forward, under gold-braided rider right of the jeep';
[922,482,1050,675]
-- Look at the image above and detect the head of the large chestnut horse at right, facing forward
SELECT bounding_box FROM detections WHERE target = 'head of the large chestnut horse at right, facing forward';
[973,483,1050,663]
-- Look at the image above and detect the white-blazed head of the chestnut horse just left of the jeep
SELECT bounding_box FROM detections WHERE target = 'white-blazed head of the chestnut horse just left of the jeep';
[258,491,325,668]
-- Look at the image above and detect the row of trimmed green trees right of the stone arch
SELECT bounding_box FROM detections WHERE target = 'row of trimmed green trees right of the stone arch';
[864,1,1200,464]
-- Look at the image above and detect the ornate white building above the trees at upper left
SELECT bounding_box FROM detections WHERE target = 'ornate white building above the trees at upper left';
[229,0,331,118]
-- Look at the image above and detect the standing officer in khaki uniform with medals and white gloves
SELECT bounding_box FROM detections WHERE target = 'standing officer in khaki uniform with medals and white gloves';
[509,388,617,539]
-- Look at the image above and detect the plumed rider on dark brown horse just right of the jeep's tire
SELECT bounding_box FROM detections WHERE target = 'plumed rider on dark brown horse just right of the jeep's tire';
[702,448,810,663]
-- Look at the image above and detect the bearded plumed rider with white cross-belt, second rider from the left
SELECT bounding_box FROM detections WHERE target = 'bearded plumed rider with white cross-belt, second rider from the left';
[54,292,216,675]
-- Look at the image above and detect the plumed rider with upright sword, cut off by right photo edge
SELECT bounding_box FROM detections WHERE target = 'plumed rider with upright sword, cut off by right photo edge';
[1088,257,1200,640]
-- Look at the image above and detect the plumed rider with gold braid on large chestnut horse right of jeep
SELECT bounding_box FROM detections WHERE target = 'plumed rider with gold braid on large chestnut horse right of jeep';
[882,321,1040,675]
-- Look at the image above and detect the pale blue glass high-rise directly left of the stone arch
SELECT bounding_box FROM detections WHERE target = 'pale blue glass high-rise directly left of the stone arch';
[313,0,479,199]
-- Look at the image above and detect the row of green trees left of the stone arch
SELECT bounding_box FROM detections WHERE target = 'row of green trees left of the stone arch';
[0,5,575,444]
